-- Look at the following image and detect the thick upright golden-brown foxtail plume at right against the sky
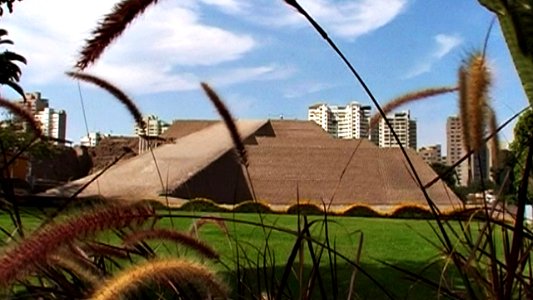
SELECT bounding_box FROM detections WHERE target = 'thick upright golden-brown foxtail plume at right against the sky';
[462,53,491,150]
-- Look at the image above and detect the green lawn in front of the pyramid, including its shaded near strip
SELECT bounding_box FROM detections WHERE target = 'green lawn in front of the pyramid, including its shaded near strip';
[0,212,466,299]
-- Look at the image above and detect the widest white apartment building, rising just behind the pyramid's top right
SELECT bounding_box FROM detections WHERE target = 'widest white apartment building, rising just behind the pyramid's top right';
[307,102,370,139]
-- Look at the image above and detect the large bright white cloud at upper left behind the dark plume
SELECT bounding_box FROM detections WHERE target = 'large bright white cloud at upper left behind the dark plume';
[2,0,256,91]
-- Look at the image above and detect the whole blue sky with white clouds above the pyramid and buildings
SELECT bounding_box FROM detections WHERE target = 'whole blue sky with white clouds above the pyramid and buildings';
[0,0,527,147]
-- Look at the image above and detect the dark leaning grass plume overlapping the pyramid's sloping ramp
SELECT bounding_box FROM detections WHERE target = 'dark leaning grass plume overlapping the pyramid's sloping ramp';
[201,82,248,166]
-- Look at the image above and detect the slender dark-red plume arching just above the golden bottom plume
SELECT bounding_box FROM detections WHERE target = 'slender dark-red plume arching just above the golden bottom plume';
[123,229,219,259]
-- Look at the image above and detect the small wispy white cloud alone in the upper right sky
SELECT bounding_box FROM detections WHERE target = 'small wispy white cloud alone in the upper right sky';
[404,34,463,79]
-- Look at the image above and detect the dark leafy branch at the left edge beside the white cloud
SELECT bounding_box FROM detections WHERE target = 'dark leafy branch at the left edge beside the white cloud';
[0,28,26,98]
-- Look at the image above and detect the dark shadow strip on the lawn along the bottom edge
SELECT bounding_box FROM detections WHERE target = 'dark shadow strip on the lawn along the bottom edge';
[222,261,458,299]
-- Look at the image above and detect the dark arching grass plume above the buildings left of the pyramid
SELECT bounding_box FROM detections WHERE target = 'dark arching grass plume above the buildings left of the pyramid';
[66,72,145,128]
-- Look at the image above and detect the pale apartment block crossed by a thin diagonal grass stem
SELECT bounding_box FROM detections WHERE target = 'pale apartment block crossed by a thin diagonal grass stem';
[378,110,417,149]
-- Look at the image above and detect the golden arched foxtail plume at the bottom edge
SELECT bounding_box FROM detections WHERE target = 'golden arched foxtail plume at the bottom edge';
[91,259,228,300]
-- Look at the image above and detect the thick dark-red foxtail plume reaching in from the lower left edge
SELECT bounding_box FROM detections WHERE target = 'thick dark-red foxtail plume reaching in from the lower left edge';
[0,204,155,286]
